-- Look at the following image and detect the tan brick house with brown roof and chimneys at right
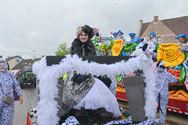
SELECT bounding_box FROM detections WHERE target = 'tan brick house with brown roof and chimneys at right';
[138,16,188,43]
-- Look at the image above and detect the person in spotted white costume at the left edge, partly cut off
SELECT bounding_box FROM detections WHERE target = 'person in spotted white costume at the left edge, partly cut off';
[0,58,23,125]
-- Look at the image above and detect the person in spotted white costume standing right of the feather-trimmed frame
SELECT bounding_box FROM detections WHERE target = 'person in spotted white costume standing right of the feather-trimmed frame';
[156,61,177,125]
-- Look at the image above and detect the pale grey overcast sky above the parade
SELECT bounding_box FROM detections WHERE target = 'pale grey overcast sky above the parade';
[0,0,188,58]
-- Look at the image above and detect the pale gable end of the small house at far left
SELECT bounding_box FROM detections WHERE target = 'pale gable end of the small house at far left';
[6,56,23,70]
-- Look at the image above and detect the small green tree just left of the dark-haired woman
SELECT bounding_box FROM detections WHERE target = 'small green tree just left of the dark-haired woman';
[55,43,69,56]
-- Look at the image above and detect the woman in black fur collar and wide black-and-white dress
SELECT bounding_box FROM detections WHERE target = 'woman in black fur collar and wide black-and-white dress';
[62,25,121,124]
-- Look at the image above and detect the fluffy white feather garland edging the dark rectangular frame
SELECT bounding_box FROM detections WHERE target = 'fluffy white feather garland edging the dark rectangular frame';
[33,53,157,125]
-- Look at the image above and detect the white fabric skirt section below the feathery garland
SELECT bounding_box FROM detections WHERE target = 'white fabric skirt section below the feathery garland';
[74,78,121,117]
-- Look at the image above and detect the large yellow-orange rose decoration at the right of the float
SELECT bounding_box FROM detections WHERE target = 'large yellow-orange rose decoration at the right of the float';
[157,43,185,67]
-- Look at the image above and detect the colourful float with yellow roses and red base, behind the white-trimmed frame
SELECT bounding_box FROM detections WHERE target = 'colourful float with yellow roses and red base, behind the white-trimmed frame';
[94,31,188,115]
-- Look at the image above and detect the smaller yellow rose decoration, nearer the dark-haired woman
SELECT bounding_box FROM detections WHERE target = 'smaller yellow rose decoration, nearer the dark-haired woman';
[112,39,123,56]
